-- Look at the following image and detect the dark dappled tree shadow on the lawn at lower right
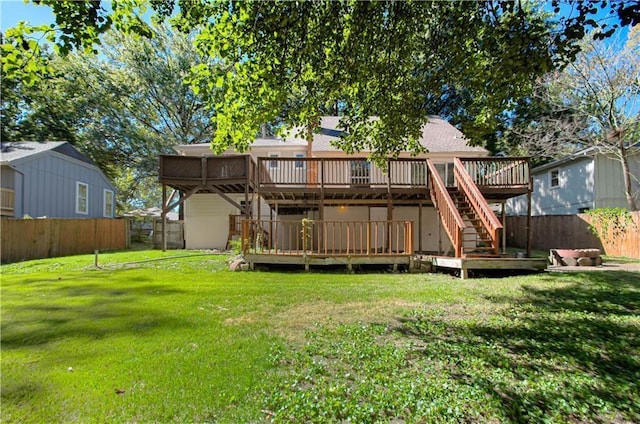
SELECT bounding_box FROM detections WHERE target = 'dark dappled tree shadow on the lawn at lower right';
[400,272,640,422]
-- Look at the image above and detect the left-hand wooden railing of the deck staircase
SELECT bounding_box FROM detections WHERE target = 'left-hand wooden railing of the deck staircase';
[427,159,465,258]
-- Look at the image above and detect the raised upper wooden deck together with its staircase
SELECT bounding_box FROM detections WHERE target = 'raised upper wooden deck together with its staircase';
[160,155,531,257]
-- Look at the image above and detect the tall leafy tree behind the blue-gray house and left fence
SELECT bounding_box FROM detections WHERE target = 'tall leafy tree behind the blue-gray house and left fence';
[3,25,213,212]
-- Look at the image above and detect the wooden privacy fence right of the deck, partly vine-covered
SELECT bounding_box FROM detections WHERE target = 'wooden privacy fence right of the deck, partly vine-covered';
[506,211,640,259]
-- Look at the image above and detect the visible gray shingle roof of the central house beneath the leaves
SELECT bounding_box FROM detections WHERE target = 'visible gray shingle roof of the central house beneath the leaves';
[288,115,488,153]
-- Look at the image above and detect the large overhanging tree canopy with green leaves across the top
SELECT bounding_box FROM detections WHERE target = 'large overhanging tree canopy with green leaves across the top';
[3,0,639,164]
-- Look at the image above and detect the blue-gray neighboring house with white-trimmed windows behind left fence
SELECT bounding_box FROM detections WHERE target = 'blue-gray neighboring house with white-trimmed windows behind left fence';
[0,141,116,218]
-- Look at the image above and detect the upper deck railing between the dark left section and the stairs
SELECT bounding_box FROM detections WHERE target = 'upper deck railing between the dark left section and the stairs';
[258,157,427,188]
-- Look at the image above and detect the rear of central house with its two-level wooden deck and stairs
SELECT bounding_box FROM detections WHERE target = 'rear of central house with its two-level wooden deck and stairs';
[159,116,530,268]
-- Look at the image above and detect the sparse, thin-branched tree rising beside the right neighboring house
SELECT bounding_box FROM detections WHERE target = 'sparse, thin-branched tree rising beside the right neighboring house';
[512,26,640,210]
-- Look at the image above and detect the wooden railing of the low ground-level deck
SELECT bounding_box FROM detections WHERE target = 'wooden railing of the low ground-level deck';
[242,219,413,256]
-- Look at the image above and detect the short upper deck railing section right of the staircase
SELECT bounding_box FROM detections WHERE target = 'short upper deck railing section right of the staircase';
[459,157,530,188]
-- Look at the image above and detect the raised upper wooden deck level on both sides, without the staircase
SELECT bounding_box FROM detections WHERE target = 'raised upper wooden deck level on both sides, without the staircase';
[159,155,529,209]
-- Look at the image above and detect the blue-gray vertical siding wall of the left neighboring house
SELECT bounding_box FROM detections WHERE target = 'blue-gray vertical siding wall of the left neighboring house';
[13,152,115,218]
